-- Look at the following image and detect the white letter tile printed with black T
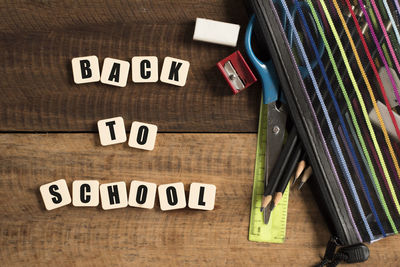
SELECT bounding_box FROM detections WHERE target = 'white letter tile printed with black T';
[97,117,126,146]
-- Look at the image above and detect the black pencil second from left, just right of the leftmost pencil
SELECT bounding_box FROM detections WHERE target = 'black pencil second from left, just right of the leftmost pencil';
[271,142,303,210]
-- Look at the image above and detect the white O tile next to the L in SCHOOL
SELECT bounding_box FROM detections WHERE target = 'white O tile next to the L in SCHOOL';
[158,183,186,211]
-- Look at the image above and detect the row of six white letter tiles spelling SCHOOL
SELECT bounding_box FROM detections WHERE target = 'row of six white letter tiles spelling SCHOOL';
[40,179,216,211]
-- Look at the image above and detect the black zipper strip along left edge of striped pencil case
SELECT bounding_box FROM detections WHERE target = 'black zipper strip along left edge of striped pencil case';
[256,1,362,246]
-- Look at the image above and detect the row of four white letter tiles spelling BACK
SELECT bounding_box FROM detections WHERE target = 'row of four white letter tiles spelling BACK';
[72,56,190,87]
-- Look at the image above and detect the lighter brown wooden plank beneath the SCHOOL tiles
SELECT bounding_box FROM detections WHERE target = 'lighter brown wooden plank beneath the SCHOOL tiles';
[0,134,338,266]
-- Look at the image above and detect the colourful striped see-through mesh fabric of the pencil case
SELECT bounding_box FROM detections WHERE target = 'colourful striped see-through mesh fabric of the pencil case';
[269,0,400,241]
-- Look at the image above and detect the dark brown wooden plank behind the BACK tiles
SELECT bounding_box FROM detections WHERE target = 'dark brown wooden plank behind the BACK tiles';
[0,0,261,132]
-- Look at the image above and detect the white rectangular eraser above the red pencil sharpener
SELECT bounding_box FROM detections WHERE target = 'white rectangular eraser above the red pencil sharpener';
[193,18,240,47]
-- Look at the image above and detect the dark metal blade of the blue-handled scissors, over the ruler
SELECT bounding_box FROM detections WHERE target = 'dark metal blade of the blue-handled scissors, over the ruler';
[264,102,287,194]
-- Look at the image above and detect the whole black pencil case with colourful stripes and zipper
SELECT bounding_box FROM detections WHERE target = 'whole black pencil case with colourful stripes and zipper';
[249,0,400,264]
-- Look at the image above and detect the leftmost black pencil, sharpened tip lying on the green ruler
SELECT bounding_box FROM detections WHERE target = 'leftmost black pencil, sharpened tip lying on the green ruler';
[261,125,298,211]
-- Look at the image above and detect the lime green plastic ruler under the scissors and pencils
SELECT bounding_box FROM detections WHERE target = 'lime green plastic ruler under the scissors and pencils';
[249,99,290,243]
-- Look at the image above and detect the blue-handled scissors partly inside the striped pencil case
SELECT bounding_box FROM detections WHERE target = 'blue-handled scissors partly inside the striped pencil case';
[245,2,325,224]
